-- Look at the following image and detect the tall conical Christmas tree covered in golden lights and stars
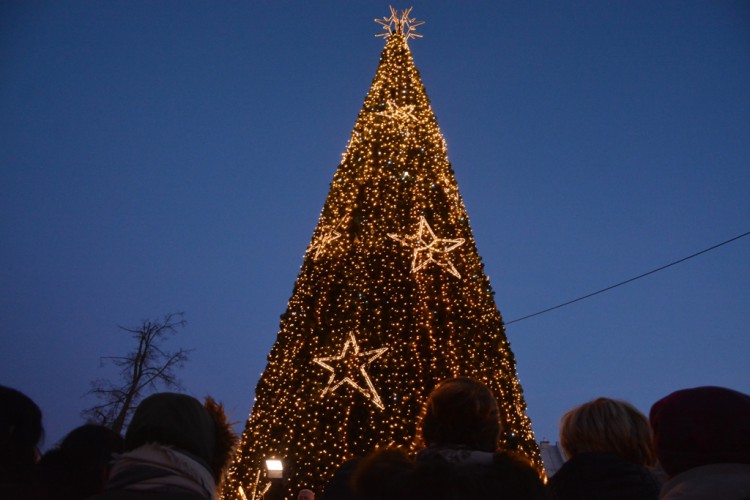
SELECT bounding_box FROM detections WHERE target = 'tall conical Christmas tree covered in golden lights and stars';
[224,9,542,499]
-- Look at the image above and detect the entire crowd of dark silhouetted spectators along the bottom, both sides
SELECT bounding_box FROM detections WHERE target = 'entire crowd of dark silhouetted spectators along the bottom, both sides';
[0,377,750,500]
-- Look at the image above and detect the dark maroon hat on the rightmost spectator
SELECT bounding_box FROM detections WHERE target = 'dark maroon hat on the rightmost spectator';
[649,387,750,477]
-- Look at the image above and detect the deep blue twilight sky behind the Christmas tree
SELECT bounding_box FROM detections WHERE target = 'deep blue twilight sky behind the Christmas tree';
[0,0,750,448]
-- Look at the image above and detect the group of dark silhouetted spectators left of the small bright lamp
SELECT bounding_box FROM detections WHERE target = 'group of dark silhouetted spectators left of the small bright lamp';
[0,386,237,500]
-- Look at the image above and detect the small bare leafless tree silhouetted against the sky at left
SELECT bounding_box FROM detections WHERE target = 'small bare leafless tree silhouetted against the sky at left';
[82,313,192,433]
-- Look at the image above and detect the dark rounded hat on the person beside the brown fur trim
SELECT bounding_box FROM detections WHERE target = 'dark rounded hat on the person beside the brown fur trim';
[125,392,216,470]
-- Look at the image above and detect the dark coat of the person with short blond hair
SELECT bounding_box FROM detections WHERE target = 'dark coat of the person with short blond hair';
[547,453,661,500]
